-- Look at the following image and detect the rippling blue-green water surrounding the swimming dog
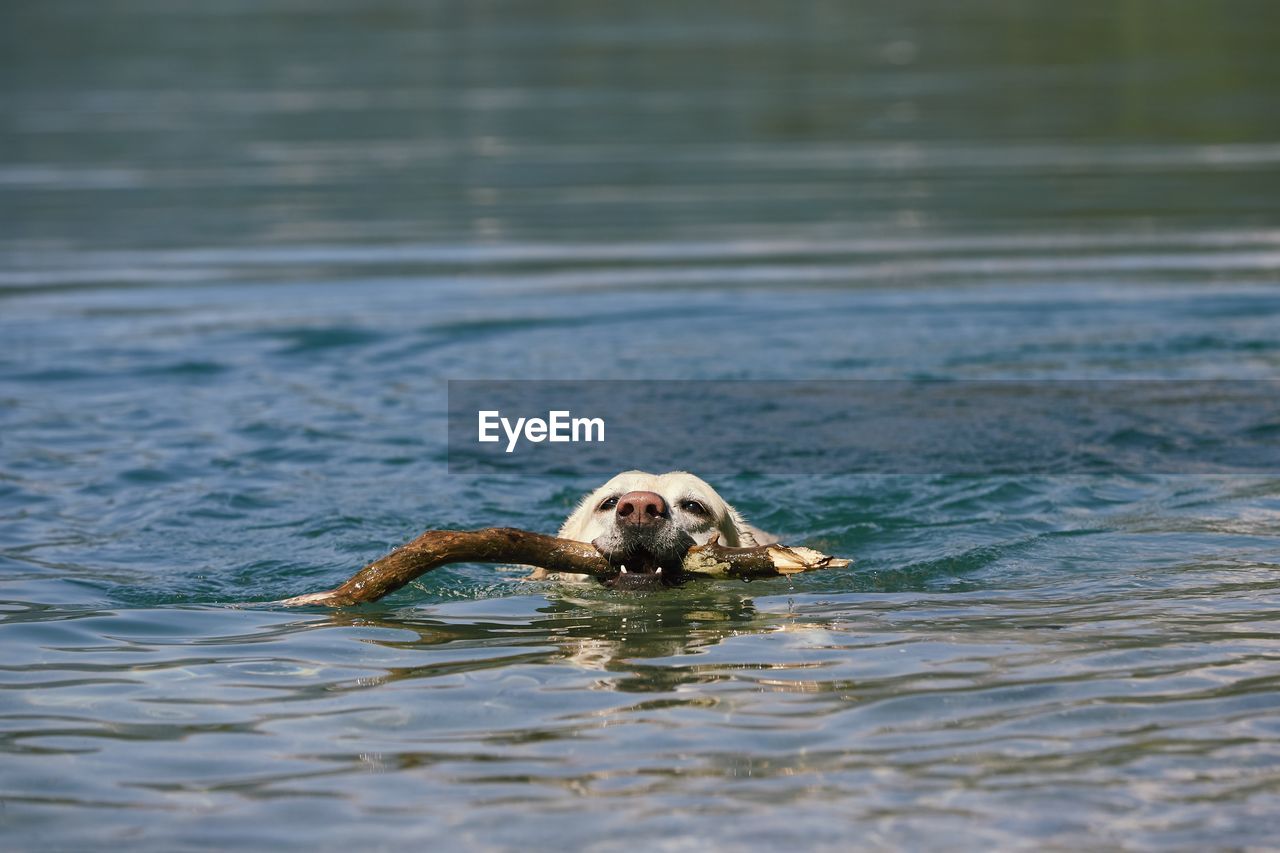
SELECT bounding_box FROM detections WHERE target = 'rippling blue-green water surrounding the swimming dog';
[0,0,1280,850]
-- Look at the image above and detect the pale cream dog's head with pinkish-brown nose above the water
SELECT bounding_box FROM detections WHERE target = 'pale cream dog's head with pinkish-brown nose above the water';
[531,471,778,589]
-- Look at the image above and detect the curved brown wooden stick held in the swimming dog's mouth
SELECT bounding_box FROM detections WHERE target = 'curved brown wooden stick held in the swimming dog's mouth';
[279,528,850,607]
